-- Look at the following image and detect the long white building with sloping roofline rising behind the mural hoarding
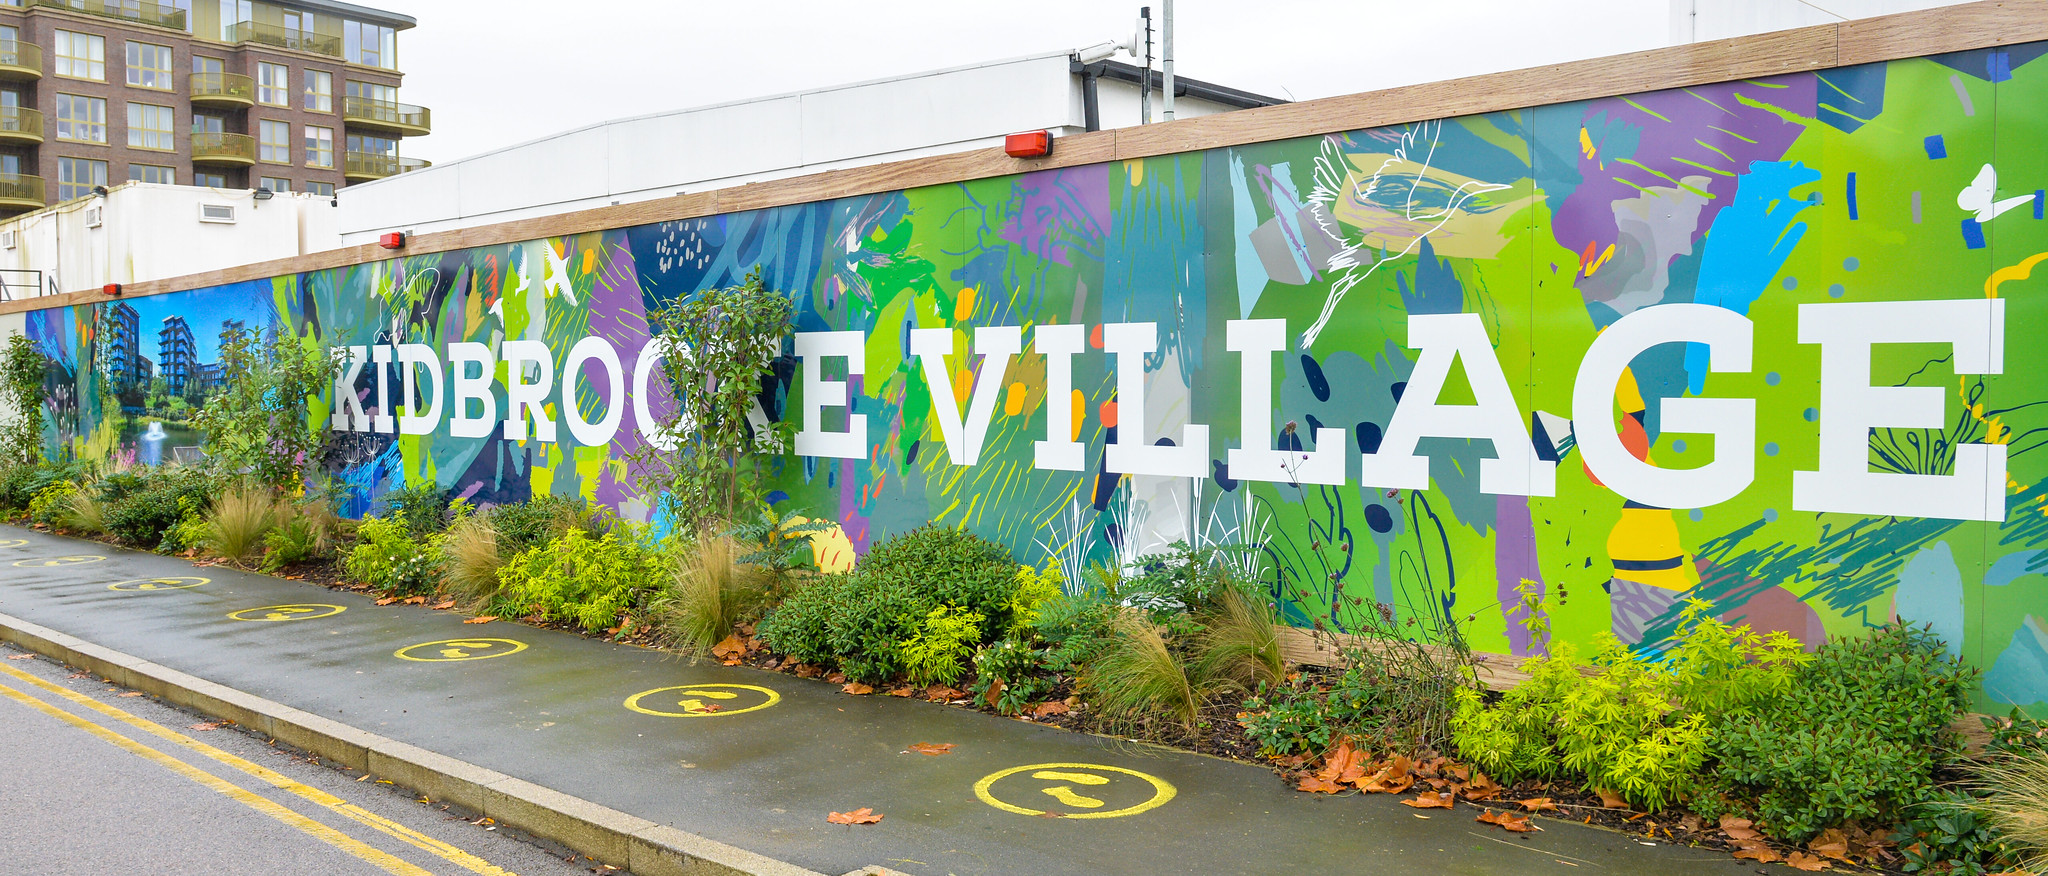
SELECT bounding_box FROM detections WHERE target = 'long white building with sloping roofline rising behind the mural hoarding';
[340,53,1233,246]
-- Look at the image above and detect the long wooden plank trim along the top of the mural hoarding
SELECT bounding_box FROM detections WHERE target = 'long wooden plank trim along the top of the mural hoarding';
[0,0,2048,313]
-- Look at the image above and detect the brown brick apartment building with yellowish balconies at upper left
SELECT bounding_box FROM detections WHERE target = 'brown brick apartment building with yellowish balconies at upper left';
[0,0,432,217]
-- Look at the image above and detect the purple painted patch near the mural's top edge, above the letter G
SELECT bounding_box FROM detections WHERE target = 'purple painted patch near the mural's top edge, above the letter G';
[1550,76,1817,304]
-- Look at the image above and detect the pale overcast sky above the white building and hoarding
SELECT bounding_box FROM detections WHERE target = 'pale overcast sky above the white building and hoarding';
[395,0,1671,162]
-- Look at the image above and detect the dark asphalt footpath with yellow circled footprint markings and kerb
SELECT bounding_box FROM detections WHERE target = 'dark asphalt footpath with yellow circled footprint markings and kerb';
[0,526,1753,876]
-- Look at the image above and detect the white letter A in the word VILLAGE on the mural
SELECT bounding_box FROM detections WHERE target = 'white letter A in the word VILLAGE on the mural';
[1358,313,1556,495]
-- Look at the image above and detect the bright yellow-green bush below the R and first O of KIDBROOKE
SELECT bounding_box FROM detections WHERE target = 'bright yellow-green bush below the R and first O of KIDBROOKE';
[492,526,662,632]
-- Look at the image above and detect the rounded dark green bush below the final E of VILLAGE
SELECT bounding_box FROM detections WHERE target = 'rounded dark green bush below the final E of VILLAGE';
[1712,624,1976,841]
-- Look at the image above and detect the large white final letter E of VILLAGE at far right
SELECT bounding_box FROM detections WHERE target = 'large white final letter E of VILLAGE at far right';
[1792,299,2005,520]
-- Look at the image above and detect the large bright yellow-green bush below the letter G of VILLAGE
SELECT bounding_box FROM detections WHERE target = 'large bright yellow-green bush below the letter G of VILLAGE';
[1452,602,1806,814]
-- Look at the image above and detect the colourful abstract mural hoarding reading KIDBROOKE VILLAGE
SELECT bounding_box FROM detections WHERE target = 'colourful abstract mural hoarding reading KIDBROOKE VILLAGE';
[25,45,2048,714]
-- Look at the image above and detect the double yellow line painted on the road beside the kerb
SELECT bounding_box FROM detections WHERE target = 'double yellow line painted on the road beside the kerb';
[0,665,512,876]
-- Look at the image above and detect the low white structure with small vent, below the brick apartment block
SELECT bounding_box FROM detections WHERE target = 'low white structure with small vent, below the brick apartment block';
[0,182,342,299]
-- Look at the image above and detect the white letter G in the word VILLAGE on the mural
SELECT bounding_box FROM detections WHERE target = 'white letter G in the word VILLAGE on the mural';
[1571,305,1757,508]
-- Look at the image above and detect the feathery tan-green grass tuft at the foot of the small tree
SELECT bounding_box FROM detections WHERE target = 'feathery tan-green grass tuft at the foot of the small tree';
[647,534,774,657]
